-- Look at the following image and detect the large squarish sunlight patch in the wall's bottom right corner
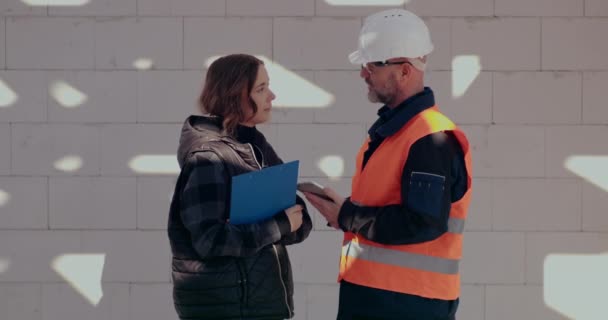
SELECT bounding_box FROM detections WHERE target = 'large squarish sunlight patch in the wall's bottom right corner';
[543,253,608,320]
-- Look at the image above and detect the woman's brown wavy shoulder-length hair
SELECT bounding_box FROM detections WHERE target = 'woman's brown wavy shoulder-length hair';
[199,54,264,136]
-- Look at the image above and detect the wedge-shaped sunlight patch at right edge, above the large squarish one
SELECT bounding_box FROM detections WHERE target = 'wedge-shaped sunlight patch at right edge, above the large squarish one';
[564,155,608,192]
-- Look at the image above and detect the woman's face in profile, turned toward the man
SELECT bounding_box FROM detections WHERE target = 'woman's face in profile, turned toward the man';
[242,65,276,127]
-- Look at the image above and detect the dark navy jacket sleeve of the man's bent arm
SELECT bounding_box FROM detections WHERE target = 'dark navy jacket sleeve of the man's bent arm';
[338,132,466,245]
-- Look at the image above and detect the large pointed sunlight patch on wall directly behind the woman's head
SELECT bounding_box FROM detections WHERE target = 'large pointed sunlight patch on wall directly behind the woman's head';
[205,56,335,108]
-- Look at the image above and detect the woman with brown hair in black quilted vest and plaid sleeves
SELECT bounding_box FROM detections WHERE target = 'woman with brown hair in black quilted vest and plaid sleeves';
[168,54,312,319]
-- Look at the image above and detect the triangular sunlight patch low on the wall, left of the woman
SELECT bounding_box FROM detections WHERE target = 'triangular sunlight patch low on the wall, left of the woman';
[51,254,106,306]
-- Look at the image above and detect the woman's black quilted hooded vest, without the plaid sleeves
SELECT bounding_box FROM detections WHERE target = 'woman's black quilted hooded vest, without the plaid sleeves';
[168,116,293,320]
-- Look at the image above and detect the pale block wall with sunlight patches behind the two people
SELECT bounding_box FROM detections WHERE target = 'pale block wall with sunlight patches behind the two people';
[0,0,608,320]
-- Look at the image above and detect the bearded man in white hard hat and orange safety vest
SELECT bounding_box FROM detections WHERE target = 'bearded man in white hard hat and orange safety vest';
[306,9,471,320]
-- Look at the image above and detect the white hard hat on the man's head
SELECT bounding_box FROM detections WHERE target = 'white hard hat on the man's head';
[348,9,433,68]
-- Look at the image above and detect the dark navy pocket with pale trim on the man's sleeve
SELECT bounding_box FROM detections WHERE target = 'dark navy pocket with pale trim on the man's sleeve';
[407,171,445,218]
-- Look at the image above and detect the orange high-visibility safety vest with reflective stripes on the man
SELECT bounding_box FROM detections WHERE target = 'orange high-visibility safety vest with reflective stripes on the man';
[338,106,472,300]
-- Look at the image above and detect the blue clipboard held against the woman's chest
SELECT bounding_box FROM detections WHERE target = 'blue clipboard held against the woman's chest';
[230,160,300,225]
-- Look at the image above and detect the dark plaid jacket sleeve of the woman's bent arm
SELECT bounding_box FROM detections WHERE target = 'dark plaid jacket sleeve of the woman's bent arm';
[180,152,290,258]
